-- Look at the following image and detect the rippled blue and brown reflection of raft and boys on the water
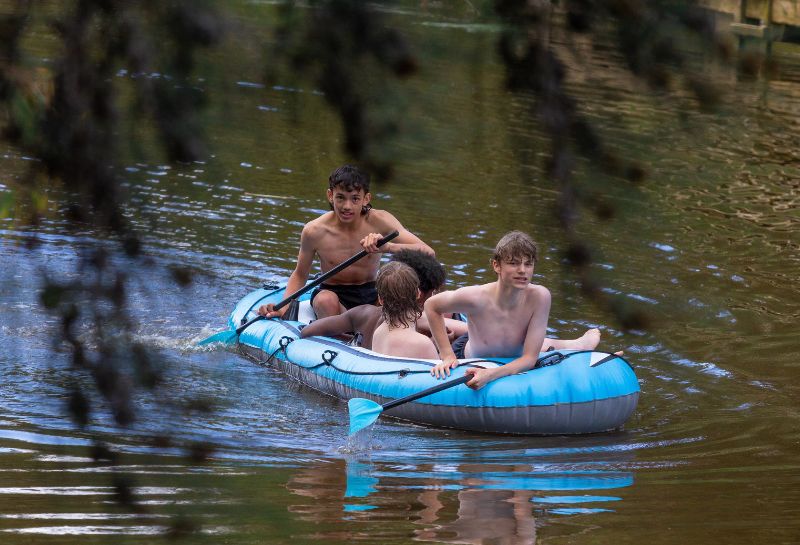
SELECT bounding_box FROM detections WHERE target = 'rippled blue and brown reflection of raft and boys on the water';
[287,446,634,544]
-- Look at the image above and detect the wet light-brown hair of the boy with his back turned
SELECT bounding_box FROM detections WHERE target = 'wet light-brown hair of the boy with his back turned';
[375,261,422,327]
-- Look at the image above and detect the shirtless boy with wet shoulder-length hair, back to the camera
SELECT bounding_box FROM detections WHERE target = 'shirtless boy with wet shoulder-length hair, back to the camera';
[372,261,438,359]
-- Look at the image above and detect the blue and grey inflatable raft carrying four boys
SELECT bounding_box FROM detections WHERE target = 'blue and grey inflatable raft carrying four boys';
[229,289,639,434]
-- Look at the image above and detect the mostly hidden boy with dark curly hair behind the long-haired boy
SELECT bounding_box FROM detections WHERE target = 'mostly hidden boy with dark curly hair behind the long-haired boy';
[300,250,467,349]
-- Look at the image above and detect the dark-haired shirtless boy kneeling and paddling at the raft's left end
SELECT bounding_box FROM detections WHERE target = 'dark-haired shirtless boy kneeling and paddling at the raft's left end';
[258,165,433,318]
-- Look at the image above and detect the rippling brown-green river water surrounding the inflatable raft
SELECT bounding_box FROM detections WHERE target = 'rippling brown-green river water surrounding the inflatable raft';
[0,3,800,545]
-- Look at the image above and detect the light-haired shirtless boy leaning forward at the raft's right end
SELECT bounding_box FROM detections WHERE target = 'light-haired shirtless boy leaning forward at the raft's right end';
[425,231,600,390]
